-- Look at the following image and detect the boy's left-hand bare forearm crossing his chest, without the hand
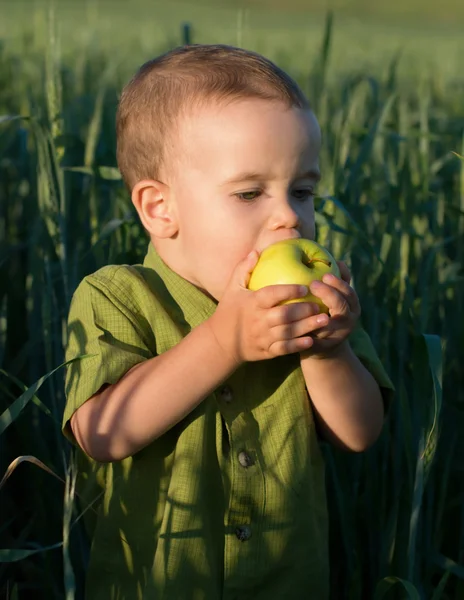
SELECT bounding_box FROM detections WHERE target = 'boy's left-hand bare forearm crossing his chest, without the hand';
[71,323,237,462]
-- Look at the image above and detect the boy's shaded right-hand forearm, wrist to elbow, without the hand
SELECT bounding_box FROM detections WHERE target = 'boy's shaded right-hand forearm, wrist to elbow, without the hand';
[301,341,384,452]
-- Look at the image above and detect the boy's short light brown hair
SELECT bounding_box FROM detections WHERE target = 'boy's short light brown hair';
[116,44,309,190]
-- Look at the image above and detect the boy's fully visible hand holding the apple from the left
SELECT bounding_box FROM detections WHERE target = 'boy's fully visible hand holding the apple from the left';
[206,250,329,367]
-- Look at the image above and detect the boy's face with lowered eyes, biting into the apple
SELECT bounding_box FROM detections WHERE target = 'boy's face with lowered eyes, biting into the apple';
[163,99,321,300]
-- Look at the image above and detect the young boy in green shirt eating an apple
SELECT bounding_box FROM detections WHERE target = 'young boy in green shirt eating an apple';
[63,45,393,600]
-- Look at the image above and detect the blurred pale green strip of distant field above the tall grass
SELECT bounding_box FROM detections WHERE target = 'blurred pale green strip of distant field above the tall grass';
[0,0,464,80]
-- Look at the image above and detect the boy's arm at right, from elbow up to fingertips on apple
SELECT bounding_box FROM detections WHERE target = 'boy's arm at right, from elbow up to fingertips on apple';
[300,262,393,452]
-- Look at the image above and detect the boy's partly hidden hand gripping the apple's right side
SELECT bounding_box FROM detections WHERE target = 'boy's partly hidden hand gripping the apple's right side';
[300,261,361,359]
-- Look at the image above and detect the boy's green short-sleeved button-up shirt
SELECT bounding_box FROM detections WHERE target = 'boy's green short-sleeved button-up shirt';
[63,244,393,600]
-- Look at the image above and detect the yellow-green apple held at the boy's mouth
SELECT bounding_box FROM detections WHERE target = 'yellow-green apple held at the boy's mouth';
[248,238,340,314]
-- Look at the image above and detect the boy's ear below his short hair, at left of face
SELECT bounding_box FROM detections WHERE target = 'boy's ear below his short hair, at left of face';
[131,179,178,238]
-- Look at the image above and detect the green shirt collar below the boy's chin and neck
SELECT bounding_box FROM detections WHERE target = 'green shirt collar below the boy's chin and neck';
[143,242,217,327]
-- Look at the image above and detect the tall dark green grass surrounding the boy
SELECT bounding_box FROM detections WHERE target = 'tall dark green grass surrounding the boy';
[0,0,464,600]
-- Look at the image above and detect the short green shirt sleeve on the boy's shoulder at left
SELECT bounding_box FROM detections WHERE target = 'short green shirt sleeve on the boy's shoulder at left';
[62,265,155,444]
